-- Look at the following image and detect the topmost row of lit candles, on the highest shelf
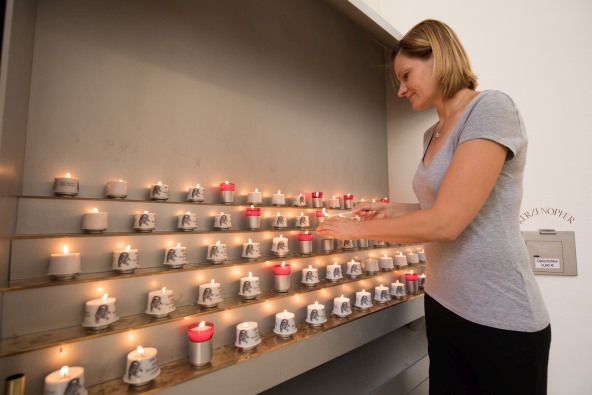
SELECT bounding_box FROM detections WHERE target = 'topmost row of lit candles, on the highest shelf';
[53,173,389,209]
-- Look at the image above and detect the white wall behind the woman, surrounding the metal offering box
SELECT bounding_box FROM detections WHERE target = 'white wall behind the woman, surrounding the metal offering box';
[365,0,592,394]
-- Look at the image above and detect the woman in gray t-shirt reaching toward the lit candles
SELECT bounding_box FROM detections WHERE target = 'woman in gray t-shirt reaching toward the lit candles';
[317,20,551,394]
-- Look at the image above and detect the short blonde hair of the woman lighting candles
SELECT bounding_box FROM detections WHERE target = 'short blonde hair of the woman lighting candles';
[391,19,477,98]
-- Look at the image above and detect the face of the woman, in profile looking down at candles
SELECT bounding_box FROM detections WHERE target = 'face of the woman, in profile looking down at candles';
[394,53,441,111]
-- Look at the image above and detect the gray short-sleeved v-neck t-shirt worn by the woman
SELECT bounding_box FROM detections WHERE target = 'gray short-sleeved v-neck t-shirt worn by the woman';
[413,91,549,332]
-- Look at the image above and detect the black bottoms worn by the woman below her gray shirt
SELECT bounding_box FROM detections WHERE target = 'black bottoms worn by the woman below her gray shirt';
[425,294,551,395]
